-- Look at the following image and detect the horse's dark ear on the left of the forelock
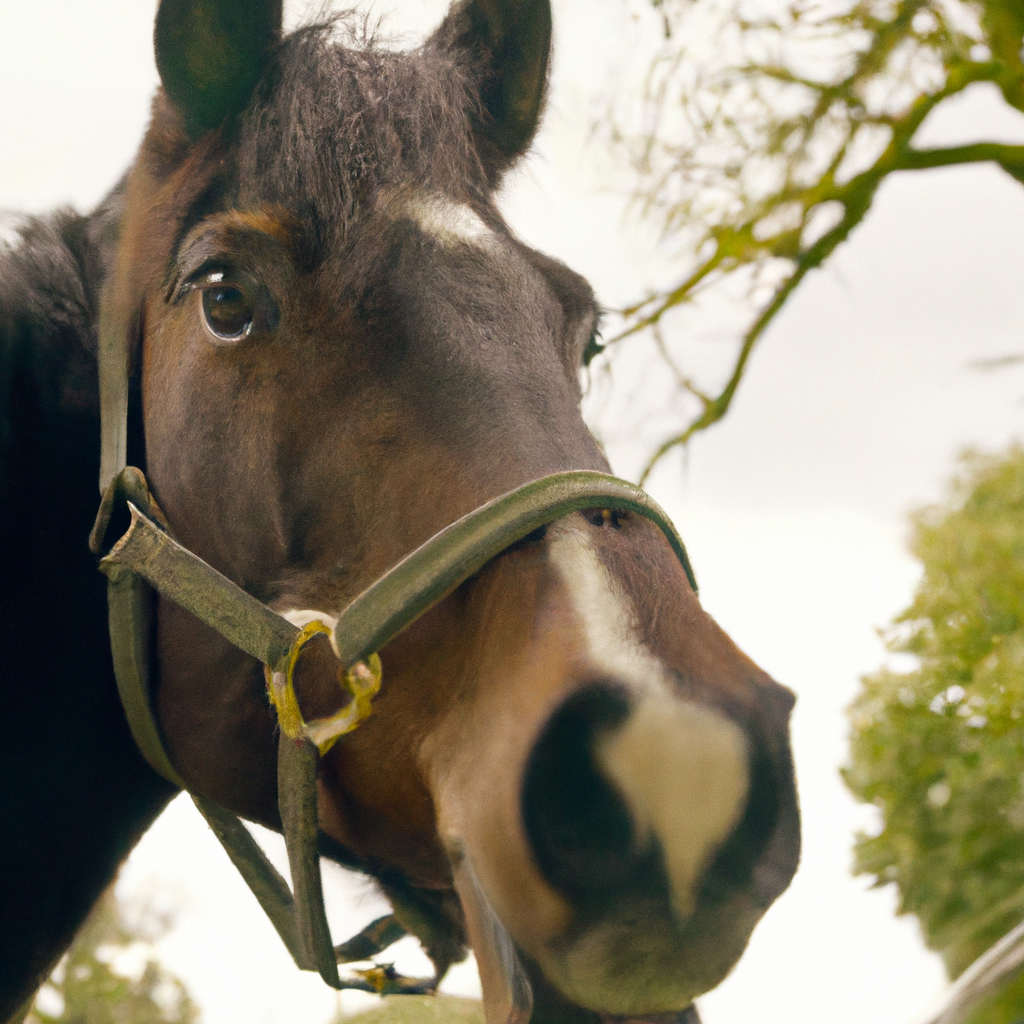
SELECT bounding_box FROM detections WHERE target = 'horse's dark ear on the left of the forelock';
[154,0,283,138]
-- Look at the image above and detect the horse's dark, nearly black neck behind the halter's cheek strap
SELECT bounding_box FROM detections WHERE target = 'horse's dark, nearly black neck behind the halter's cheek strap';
[0,180,172,1020]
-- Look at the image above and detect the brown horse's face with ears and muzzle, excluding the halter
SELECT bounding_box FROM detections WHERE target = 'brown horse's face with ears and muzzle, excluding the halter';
[105,0,799,1020]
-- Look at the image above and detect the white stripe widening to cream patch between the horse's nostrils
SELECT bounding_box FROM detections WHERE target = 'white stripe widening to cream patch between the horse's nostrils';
[549,530,750,920]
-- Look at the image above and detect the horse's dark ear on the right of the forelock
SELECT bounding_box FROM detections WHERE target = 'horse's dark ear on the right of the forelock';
[433,0,551,170]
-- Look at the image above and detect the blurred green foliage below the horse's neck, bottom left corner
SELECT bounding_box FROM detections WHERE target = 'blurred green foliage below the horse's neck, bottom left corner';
[26,889,199,1024]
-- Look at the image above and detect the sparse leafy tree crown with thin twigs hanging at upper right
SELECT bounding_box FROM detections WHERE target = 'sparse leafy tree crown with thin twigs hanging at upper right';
[602,0,1024,475]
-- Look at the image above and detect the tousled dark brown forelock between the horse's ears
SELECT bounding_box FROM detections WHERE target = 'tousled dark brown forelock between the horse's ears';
[238,20,489,241]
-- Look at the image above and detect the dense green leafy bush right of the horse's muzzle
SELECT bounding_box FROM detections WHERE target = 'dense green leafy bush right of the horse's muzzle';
[844,446,1024,1024]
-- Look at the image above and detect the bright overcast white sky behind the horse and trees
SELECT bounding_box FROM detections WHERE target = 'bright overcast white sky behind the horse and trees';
[6,0,1024,1024]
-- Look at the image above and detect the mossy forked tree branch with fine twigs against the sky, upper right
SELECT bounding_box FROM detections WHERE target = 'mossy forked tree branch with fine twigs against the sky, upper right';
[603,0,1024,481]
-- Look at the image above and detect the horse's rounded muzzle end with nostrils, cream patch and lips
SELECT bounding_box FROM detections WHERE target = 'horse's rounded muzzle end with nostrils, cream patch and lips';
[444,679,797,1019]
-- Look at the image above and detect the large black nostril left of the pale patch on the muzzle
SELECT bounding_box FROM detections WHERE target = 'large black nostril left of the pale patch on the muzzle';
[522,681,637,897]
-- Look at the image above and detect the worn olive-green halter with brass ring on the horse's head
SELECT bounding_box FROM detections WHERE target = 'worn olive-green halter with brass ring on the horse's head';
[89,316,696,994]
